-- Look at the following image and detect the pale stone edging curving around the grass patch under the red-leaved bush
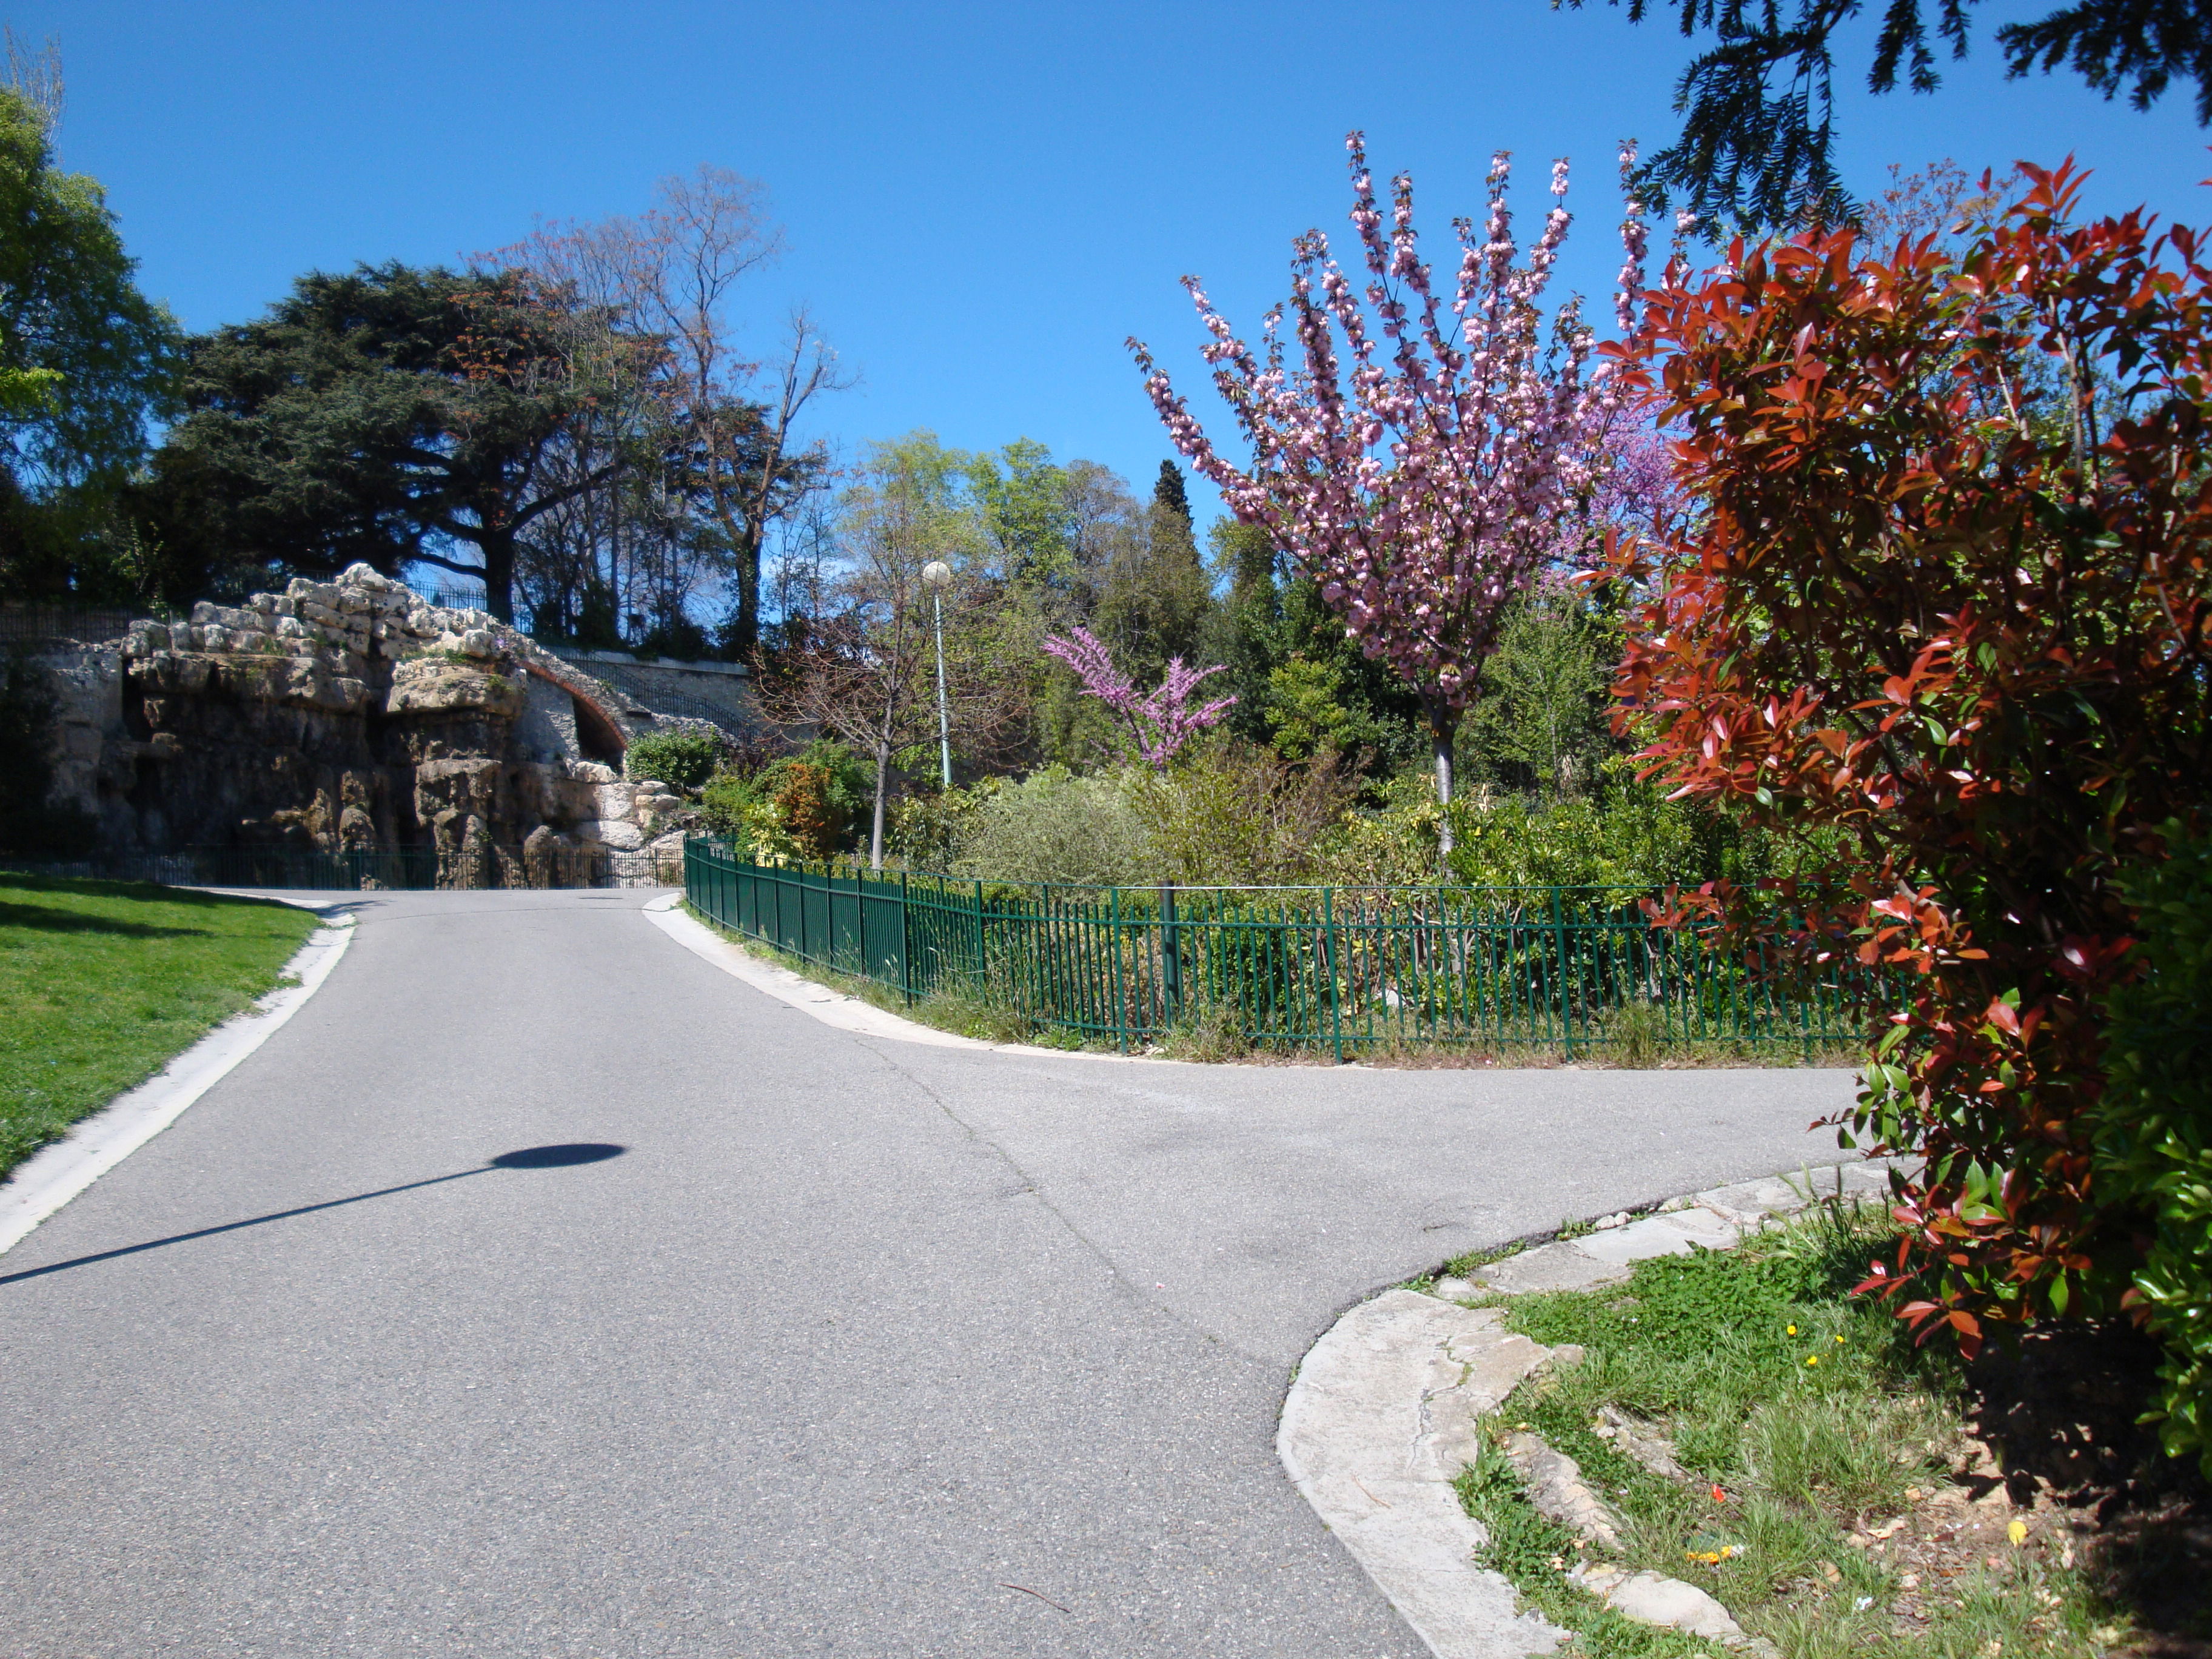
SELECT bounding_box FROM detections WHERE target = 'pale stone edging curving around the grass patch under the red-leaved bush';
[1274,1161,1889,1659]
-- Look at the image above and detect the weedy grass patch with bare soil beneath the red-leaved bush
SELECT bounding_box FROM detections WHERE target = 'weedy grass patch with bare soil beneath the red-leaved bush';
[1460,1201,2126,1659]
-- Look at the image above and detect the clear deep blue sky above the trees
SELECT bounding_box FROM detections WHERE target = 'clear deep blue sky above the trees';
[30,0,2212,526]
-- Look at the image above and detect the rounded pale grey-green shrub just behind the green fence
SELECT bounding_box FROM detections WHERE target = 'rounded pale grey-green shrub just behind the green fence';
[953,765,1157,887]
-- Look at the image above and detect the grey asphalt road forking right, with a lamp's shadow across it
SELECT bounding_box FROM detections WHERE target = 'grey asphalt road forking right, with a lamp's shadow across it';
[0,894,1849,1659]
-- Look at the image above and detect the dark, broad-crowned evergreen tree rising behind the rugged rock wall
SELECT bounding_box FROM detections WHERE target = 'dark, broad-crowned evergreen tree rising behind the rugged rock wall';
[150,261,624,617]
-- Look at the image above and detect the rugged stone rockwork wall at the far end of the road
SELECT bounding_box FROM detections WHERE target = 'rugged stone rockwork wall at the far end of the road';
[38,564,748,860]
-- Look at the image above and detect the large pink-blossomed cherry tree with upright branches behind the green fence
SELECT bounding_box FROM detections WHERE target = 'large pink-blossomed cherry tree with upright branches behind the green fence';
[1128,133,1646,854]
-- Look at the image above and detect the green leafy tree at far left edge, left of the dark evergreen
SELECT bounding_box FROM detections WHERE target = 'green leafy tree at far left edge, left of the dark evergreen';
[0,89,181,597]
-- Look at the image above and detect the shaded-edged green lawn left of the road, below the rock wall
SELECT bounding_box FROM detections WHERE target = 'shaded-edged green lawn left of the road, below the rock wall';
[0,871,317,1177]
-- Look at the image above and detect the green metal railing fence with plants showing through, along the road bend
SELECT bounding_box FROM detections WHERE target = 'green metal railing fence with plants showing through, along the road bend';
[683,839,1865,1059]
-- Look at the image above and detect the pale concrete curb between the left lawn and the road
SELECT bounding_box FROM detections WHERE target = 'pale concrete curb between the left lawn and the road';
[0,898,354,1254]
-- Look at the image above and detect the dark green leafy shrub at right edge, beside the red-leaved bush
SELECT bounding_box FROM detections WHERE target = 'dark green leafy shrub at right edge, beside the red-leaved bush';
[2095,825,2212,1473]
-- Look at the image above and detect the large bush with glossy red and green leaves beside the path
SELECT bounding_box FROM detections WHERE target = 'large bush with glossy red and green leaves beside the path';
[1615,168,2212,1352]
